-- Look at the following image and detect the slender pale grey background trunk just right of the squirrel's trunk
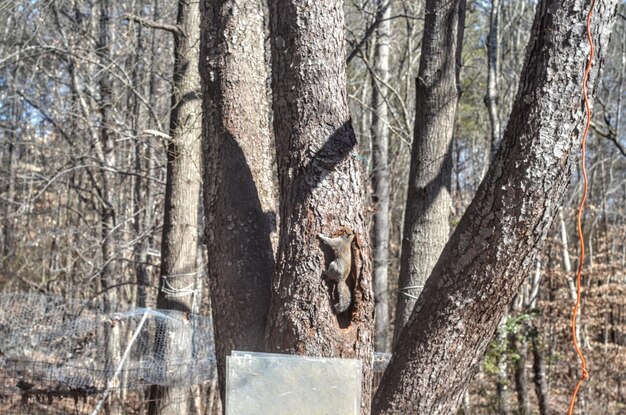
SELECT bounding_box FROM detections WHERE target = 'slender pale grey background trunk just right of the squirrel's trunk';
[372,2,391,352]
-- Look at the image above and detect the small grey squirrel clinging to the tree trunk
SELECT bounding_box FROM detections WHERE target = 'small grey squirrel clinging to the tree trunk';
[317,227,354,314]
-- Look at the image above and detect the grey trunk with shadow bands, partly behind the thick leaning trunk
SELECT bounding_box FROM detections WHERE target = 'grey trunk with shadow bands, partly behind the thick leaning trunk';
[394,0,465,341]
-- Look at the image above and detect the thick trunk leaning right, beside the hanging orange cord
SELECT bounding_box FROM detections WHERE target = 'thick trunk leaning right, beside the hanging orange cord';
[374,0,615,414]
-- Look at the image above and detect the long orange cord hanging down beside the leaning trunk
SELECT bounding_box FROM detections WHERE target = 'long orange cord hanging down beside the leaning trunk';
[567,0,595,415]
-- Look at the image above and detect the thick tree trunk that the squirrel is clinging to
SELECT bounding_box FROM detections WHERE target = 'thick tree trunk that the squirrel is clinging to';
[267,0,374,413]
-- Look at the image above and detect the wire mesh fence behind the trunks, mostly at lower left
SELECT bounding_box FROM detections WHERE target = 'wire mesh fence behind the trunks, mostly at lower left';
[0,294,390,415]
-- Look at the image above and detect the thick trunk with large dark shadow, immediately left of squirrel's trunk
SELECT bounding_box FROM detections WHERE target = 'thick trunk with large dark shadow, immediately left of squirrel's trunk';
[200,0,276,398]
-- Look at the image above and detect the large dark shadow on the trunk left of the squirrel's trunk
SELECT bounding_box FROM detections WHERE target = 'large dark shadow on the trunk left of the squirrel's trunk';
[204,127,275,406]
